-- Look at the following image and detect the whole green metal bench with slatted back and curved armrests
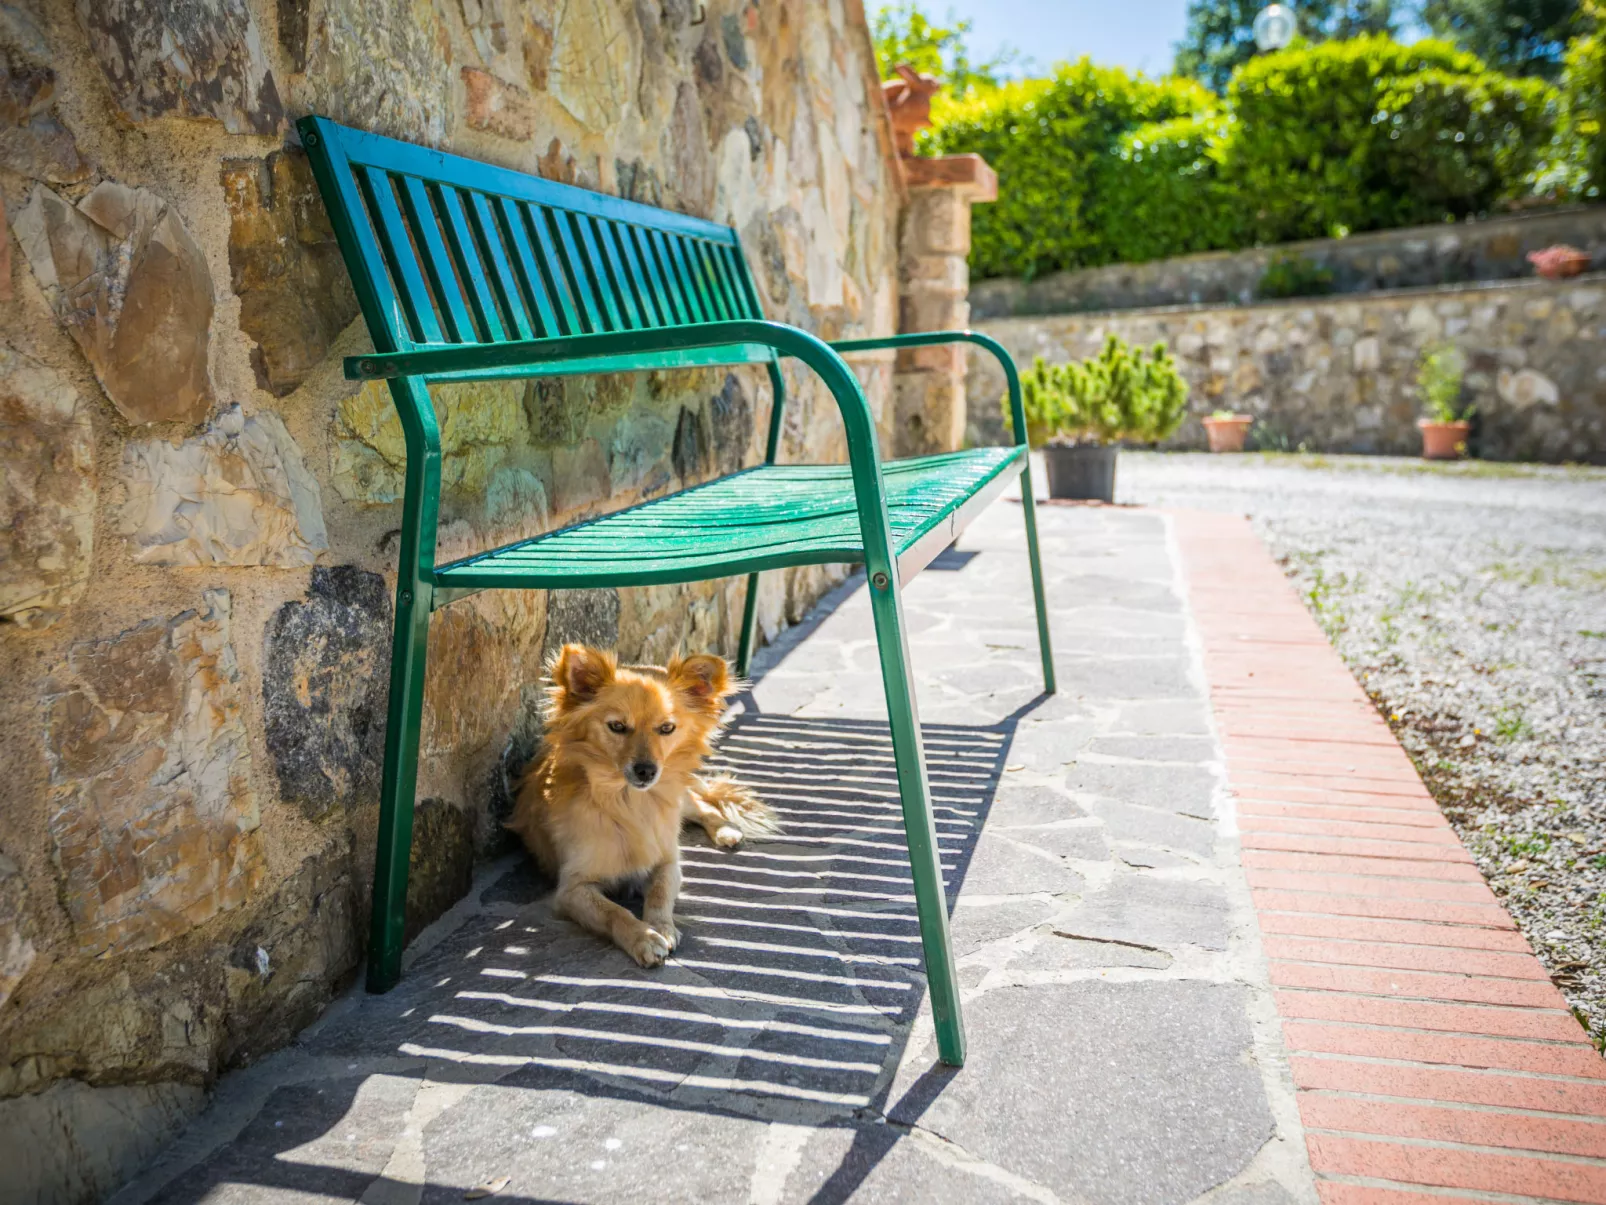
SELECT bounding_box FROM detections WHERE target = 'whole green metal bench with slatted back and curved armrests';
[299,117,1054,1067]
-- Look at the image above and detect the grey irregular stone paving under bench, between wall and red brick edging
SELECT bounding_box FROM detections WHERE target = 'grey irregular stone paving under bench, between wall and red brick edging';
[116,500,1316,1205]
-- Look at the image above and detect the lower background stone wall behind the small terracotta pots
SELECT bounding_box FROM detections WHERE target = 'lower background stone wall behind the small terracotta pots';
[968,273,1606,464]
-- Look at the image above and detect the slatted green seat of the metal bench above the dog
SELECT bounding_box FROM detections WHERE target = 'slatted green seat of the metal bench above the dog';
[435,447,1025,598]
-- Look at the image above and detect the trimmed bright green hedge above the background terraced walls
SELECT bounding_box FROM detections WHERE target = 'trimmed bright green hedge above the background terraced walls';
[922,37,1556,278]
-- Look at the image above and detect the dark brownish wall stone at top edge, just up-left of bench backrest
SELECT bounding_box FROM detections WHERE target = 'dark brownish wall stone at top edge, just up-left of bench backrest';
[77,0,284,133]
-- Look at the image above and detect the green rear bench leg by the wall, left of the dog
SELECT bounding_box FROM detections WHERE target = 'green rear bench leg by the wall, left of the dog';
[368,578,430,991]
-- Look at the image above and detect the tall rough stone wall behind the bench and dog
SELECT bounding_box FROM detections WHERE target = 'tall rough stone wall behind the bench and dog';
[0,0,901,1200]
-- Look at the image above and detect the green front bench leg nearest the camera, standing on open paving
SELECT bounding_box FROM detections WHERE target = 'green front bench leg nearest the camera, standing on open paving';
[867,566,965,1067]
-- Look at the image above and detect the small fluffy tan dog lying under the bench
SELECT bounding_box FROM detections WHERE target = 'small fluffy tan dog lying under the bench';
[507,644,776,967]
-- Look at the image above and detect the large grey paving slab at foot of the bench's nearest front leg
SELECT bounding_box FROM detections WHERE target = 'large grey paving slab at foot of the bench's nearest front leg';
[887,982,1274,1205]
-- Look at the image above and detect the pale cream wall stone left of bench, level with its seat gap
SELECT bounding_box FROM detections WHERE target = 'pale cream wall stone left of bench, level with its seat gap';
[119,406,329,569]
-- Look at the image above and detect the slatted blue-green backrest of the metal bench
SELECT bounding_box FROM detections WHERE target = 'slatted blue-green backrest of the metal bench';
[297,117,768,368]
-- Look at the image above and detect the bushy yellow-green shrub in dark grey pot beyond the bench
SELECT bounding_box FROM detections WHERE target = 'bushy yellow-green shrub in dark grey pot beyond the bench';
[1004,334,1188,501]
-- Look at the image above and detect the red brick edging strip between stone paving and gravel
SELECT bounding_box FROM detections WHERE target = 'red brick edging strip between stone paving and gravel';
[1172,513,1606,1205]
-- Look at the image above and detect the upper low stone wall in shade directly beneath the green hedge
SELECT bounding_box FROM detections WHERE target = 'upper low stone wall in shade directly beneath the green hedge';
[970,206,1606,320]
